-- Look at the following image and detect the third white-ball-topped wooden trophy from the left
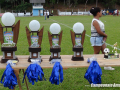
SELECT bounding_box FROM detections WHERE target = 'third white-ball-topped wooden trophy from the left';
[48,23,63,61]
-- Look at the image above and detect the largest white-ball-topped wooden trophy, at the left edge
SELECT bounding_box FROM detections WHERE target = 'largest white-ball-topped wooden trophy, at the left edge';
[0,12,20,63]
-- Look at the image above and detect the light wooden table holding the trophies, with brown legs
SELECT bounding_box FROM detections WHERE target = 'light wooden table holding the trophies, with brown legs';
[0,54,120,90]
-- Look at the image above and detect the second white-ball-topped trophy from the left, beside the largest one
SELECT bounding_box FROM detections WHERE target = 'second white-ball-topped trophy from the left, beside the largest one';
[26,20,44,62]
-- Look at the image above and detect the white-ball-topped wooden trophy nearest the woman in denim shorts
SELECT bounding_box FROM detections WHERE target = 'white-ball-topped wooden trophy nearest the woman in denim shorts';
[70,22,86,61]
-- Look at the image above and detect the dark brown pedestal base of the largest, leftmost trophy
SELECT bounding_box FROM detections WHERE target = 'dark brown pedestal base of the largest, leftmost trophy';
[1,47,19,63]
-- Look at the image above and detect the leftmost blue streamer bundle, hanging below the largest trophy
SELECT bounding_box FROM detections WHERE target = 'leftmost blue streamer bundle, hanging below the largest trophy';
[1,64,17,89]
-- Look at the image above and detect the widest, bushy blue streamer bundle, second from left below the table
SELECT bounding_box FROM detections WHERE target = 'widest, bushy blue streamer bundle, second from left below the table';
[23,64,46,85]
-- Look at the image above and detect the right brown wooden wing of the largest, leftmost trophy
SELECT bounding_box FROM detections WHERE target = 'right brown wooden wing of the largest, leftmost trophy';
[13,20,20,44]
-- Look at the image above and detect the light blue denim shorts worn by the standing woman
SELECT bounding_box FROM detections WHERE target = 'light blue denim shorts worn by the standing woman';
[90,37,104,46]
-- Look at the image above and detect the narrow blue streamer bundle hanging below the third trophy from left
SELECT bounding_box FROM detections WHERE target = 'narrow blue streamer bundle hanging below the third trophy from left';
[49,62,63,85]
